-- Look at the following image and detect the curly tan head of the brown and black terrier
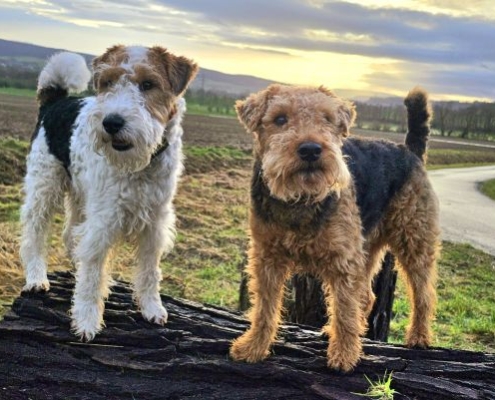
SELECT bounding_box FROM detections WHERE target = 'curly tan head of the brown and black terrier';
[236,85,355,202]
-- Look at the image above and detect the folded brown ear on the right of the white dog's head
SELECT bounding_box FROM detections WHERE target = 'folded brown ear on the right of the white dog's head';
[150,46,199,96]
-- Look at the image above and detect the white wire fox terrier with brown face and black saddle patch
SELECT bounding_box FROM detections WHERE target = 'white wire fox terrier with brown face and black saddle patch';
[20,45,198,340]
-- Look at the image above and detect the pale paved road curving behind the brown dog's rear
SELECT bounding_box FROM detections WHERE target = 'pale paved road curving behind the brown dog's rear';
[428,166,495,255]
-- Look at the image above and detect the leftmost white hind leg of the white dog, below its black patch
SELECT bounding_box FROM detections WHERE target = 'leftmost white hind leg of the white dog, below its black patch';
[20,145,68,291]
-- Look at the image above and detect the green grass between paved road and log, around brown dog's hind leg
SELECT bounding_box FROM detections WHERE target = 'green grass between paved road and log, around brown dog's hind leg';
[389,242,495,352]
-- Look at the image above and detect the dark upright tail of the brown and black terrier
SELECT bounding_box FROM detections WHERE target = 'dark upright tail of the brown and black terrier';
[404,87,433,162]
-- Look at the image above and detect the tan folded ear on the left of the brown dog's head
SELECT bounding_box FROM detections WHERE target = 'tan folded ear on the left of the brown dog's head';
[235,84,280,132]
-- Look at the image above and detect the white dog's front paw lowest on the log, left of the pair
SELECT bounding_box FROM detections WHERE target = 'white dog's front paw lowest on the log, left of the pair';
[71,301,104,342]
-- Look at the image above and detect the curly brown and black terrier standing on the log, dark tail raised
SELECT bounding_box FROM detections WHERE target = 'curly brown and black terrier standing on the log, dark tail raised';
[230,85,440,371]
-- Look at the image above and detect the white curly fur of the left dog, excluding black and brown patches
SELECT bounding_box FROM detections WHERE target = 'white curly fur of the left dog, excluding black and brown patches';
[21,49,186,340]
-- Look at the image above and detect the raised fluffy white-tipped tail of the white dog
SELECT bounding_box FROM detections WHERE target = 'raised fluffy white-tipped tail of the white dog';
[37,52,91,106]
